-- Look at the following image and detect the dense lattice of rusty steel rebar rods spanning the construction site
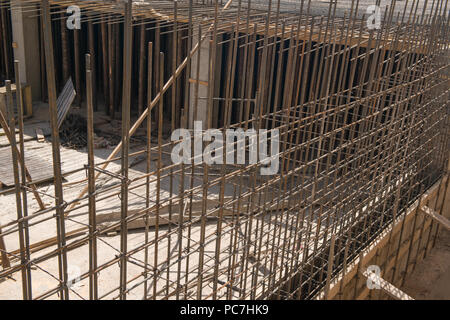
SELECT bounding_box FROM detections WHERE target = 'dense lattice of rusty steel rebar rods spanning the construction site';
[0,0,450,299]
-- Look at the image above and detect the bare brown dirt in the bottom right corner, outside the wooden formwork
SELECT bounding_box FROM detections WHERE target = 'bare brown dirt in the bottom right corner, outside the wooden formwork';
[401,228,450,300]
